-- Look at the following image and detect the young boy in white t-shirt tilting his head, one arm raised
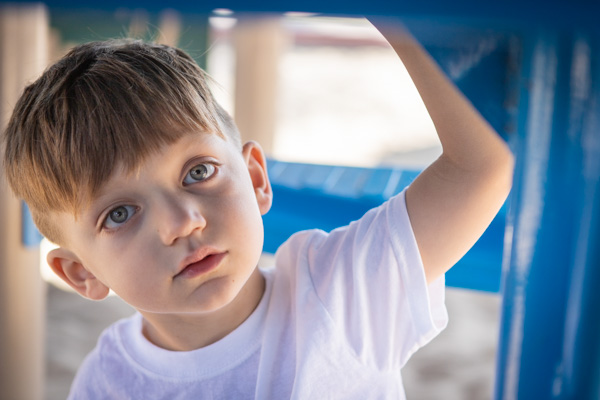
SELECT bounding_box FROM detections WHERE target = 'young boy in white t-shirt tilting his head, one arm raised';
[4,19,512,399]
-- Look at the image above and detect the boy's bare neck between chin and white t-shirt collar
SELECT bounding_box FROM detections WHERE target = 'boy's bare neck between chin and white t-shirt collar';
[141,268,265,351]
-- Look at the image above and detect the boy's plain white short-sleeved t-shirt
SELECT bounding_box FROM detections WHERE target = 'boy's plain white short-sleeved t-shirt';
[70,192,448,400]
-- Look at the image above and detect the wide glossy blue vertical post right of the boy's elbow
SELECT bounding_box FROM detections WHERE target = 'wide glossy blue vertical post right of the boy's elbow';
[496,31,600,400]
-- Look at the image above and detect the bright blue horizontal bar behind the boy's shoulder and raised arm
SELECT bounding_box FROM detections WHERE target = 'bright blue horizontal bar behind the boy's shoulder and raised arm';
[263,160,506,293]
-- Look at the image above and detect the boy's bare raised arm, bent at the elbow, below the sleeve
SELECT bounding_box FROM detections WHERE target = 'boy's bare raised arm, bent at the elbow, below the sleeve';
[371,20,513,282]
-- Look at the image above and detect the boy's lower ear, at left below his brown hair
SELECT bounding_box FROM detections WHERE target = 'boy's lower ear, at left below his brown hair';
[46,247,110,300]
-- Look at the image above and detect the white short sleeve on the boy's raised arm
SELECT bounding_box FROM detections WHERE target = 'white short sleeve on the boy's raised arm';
[284,192,447,369]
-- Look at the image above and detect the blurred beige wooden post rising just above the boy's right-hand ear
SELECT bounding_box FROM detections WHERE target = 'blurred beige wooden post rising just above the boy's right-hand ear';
[234,17,287,154]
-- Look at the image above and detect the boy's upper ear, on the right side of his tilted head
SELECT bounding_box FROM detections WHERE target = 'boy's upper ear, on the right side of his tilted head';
[242,141,273,215]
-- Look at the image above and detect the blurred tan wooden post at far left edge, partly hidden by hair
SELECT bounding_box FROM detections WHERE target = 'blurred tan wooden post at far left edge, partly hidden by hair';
[0,4,48,400]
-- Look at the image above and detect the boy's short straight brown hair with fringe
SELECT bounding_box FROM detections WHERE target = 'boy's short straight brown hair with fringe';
[4,39,240,242]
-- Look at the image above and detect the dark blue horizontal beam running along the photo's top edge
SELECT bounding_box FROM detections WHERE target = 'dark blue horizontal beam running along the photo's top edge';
[25,0,600,27]
